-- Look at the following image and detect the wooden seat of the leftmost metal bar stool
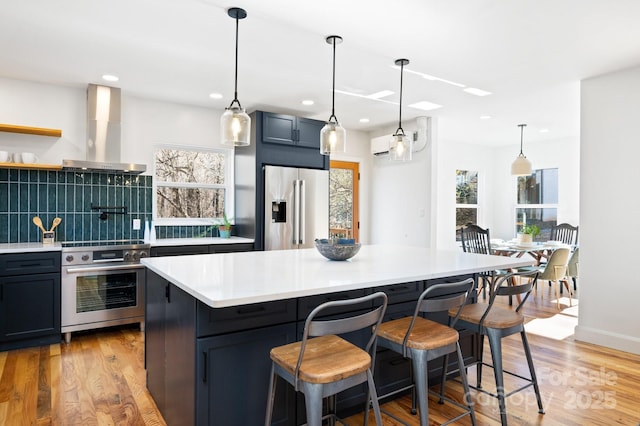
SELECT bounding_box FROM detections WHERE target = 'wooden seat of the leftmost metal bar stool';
[271,335,371,383]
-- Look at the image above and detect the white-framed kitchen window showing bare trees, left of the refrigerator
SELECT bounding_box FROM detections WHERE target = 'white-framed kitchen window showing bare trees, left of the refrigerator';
[153,146,233,225]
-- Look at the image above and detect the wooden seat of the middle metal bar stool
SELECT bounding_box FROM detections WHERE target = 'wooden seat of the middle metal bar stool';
[378,317,459,351]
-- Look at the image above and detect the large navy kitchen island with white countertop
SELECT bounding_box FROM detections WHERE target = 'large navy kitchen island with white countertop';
[142,245,533,425]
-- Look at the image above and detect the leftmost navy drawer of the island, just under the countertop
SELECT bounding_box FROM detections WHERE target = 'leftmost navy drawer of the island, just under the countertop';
[196,299,296,337]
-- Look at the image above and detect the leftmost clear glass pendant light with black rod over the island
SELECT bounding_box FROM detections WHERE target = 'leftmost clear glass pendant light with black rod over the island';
[220,7,251,146]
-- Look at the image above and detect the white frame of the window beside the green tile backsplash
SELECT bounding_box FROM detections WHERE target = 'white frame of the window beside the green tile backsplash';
[151,144,235,226]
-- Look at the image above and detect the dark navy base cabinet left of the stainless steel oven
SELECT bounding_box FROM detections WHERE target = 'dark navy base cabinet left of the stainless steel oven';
[0,252,60,351]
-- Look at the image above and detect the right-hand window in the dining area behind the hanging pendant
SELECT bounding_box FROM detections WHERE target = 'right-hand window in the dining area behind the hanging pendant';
[515,169,558,241]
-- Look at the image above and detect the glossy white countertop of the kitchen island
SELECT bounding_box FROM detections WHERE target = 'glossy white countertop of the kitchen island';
[142,245,533,308]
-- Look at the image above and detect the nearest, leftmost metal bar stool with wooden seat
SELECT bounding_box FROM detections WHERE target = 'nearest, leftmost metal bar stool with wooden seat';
[265,292,387,426]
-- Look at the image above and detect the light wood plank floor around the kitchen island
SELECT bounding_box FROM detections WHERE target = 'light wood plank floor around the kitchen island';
[0,284,640,426]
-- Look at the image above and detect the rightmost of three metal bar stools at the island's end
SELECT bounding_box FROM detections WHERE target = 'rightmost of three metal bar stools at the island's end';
[442,271,544,425]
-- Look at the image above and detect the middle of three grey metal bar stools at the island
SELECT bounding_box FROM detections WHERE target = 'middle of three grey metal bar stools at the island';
[378,278,476,426]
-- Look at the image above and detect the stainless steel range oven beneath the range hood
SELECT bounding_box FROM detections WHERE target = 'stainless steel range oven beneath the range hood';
[61,241,149,343]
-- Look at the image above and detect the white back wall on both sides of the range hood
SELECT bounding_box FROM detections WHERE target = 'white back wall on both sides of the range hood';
[0,78,228,170]
